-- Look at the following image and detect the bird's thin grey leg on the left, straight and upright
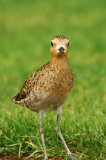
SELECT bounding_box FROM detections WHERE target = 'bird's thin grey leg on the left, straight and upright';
[39,111,49,160]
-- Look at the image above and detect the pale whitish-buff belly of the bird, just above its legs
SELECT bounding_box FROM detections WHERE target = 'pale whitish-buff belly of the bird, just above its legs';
[27,91,69,112]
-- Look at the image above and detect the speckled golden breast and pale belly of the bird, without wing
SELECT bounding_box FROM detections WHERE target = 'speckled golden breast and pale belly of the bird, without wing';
[22,60,73,111]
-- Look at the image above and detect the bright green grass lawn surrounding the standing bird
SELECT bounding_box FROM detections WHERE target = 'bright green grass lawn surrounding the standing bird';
[0,0,106,160]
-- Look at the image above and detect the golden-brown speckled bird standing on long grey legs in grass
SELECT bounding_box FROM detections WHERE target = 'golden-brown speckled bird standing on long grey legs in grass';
[11,35,75,160]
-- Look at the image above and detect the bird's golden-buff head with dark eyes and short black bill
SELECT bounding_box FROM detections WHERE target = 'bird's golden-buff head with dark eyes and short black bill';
[50,35,69,57]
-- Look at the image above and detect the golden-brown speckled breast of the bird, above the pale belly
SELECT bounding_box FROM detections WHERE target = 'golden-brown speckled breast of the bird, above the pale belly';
[33,64,73,99]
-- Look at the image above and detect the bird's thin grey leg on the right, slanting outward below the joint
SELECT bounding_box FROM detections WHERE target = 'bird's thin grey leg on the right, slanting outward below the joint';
[56,107,75,160]
